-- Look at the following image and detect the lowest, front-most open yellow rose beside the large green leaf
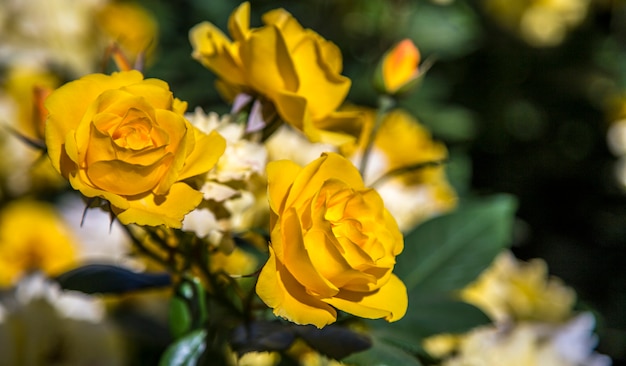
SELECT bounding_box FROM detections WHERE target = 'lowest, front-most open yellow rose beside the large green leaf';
[256,153,408,328]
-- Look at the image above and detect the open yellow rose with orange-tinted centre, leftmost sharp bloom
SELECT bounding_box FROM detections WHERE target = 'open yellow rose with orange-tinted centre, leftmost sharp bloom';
[45,70,226,228]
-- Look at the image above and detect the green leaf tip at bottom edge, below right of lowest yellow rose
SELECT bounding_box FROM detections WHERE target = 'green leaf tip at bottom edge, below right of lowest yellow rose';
[341,337,422,366]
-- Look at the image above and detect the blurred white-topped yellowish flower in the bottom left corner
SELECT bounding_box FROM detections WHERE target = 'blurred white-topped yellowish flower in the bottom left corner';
[0,274,124,366]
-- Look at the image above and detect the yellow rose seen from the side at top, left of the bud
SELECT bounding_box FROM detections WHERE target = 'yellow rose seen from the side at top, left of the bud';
[189,2,359,143]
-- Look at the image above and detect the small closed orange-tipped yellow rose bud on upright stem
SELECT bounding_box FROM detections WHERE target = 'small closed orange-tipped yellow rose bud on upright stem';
[374,38,421,95]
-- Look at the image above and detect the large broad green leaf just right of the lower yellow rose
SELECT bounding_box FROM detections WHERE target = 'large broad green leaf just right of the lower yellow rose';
[394,195,517,297]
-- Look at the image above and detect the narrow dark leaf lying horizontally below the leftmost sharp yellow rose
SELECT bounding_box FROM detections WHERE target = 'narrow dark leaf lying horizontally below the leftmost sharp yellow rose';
[56,264,172,294]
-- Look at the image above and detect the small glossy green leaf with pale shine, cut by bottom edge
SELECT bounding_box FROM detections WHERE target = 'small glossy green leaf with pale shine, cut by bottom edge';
[159,329,206,366]
